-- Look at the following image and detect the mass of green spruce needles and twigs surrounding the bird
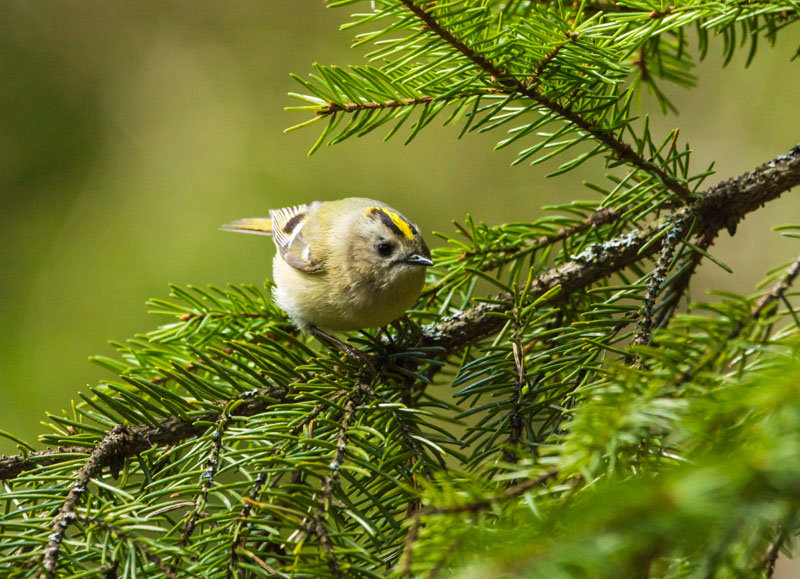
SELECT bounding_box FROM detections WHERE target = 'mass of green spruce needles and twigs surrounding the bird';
[0,0,800,577]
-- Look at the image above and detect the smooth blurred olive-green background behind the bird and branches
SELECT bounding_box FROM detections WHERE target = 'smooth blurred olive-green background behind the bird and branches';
[0,0,800,452]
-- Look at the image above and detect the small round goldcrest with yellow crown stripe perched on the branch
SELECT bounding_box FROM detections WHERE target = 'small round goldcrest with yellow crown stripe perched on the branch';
[223,197,433,331]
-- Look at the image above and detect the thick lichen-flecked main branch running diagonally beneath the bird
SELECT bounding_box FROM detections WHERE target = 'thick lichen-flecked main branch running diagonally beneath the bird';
[0,146,800,490]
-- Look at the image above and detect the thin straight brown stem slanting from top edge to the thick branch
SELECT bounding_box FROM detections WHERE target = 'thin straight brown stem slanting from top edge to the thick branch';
[399,0,692,203]
